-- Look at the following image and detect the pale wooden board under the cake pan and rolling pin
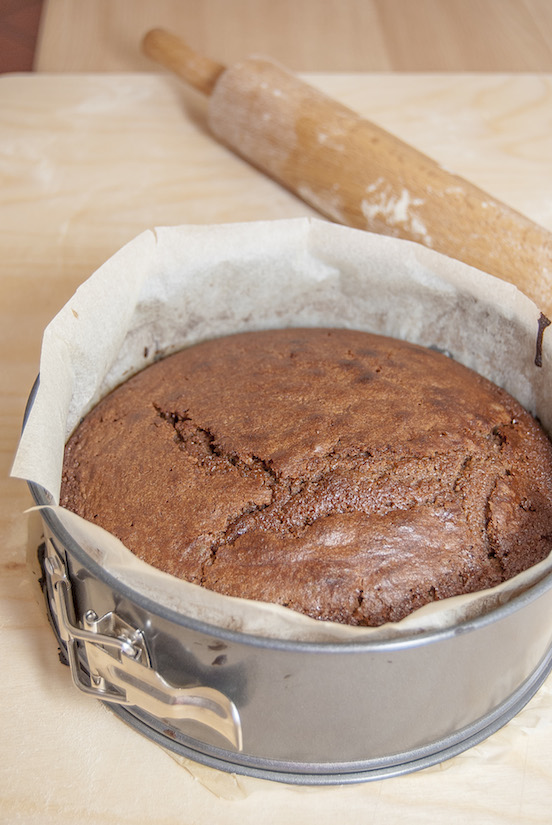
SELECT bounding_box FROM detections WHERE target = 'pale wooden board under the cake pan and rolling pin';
[0,69,552,825]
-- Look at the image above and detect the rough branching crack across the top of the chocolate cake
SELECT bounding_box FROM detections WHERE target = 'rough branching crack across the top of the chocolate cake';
[153,396,536,588]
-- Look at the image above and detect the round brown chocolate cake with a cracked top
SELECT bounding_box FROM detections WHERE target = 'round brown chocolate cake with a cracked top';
[61,329,552,626]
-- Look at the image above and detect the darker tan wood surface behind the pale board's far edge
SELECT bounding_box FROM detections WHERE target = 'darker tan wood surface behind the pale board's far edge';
[35,0,552,72]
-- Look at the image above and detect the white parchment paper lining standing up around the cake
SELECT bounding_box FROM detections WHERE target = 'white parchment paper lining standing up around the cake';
[12,218,552,641]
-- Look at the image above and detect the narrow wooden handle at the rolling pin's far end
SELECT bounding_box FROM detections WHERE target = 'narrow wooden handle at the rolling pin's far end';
[142,29,226,95]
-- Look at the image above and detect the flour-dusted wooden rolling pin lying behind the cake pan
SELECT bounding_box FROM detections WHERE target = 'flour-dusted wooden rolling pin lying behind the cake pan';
[143,29,552,315]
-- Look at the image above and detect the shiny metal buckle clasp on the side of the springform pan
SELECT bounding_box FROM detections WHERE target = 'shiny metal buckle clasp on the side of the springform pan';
[43,549,242,751]
